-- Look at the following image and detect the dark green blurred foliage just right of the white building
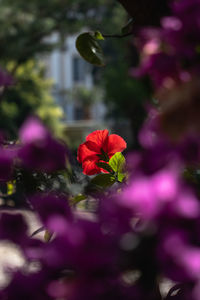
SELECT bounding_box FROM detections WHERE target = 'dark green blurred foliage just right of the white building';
[102,38,150,147]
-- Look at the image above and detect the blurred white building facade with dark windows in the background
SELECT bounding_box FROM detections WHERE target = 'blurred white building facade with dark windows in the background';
[45,33,105,126]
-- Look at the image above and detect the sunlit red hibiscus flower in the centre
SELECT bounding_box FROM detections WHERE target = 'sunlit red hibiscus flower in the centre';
[77,129,126,175]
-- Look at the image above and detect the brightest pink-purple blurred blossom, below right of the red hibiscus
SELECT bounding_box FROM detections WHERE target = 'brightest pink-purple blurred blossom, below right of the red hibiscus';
[119,168,179,219]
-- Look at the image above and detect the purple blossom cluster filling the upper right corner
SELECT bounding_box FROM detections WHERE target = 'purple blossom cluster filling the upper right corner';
[132,0,200,89]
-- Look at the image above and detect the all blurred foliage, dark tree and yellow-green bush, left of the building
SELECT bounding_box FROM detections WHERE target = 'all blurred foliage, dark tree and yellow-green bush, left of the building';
[0,0,123,138]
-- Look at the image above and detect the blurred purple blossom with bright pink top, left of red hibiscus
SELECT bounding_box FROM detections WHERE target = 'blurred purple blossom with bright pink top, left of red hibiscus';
[18,117,66,172]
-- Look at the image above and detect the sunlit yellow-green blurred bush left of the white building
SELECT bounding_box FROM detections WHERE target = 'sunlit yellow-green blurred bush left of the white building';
[0,60,63,139]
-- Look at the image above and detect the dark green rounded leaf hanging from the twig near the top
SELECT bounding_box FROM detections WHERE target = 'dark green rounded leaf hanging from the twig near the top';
[76,32,105,67]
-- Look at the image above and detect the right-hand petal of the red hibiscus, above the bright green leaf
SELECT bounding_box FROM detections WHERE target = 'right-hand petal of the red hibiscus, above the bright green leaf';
[103,134,127,157]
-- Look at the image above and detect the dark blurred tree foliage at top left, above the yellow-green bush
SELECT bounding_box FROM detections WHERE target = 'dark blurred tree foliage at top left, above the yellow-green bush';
[0,0,122,65]
